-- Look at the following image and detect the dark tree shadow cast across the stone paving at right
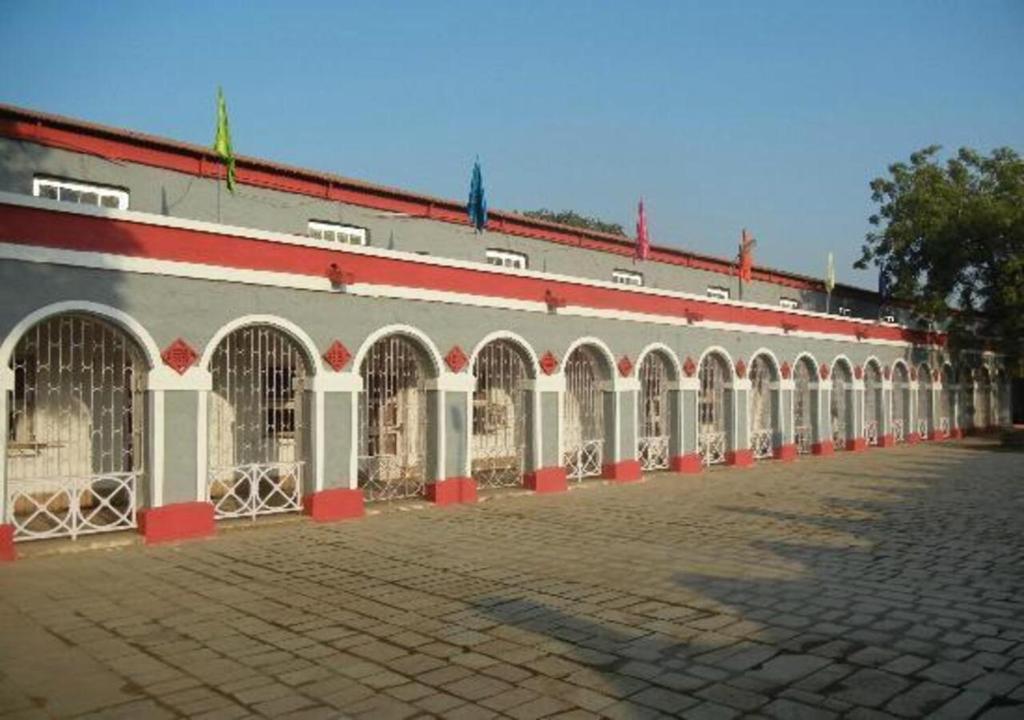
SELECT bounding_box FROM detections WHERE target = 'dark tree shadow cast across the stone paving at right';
[468,448,1024,717]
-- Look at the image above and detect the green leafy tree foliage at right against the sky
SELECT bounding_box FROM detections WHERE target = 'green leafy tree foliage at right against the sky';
[856,145,1024,361]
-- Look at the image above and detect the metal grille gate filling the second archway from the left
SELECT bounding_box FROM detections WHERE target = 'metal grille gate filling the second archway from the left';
[207,325,308,518]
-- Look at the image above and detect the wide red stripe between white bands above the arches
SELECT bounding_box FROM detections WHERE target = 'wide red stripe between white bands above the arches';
[0,205,945,345]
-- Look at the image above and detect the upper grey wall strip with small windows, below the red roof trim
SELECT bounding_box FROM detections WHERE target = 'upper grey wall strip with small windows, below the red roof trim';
[0,138,908,320]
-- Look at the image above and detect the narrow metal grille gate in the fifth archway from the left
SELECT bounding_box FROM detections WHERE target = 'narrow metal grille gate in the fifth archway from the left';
[562,347,604,480]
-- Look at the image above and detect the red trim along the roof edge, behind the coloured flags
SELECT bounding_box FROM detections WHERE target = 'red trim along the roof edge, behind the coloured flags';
[0,104,876,300]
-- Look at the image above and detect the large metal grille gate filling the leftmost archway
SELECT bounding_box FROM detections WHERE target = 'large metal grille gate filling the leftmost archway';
[6,314,146,540]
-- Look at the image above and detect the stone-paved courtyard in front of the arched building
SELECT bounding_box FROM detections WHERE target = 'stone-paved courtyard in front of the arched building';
[0,440,1024,719]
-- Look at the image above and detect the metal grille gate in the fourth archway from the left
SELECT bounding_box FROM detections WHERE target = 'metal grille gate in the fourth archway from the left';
[472,340,526,488]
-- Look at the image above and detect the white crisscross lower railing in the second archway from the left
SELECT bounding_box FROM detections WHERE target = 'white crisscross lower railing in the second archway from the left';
[207,462,304,518]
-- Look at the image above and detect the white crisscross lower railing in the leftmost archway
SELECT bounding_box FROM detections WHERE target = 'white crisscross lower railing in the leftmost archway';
[7,472,141,540]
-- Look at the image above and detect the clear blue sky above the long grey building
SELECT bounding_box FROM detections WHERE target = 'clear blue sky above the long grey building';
[0,0,1024,288]
